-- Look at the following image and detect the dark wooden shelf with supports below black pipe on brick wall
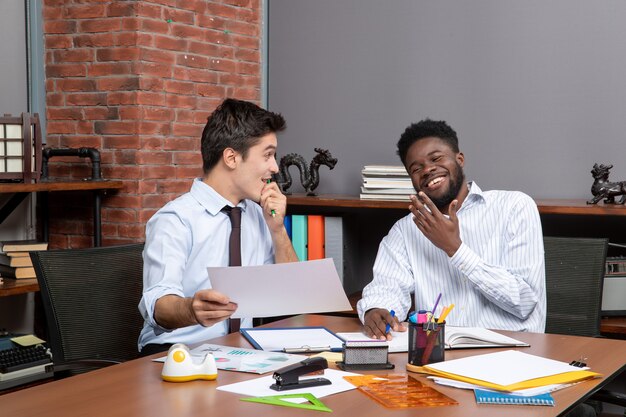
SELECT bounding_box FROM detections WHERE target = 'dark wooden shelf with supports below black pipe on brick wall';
[0,180,124,246]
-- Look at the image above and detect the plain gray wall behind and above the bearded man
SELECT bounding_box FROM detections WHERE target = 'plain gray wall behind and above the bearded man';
[267,0,626,198]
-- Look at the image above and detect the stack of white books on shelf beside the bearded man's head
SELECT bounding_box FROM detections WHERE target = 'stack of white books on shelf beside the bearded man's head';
[360,165,415,201]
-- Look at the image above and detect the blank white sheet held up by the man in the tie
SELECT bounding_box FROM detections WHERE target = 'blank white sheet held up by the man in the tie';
[207,258,352,318]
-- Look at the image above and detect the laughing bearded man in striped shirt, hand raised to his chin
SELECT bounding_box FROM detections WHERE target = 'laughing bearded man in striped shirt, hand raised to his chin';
[357,119,546,339]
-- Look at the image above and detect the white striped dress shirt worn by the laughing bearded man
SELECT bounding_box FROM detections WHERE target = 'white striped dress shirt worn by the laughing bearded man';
[357,183,546,332]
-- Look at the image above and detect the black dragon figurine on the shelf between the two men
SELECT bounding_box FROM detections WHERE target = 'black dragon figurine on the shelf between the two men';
[273,148,337,195]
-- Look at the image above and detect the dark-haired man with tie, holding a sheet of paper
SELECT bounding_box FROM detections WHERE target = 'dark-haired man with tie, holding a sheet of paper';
[139,99,298,355]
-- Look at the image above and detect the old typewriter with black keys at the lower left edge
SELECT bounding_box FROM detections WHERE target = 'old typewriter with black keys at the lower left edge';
[0,334,52,390]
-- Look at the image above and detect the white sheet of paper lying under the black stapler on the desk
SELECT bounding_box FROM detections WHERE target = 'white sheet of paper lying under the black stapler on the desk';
[217,368,356,402]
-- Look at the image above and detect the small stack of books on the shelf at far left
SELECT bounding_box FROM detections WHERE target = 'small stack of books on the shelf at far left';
[0,240,48,279]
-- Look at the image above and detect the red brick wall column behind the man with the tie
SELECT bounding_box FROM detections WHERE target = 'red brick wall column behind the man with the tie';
[43,0,262,248]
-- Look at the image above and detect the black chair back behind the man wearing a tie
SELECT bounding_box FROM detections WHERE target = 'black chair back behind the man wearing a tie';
[30,243,144,377]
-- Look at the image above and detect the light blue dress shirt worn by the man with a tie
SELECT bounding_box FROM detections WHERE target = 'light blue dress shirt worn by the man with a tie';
[139,178,274,350]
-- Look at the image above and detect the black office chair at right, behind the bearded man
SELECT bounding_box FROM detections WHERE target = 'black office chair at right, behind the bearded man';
[543,236,626,415]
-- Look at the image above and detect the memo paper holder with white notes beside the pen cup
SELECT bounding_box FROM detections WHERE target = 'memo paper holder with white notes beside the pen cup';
[337,340,395,371]
